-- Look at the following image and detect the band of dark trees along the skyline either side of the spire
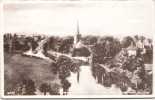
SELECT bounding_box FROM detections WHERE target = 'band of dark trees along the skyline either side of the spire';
[4,34,153,60]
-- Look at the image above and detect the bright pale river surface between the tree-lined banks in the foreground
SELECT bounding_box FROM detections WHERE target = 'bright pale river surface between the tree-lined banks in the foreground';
[68,66,122,95]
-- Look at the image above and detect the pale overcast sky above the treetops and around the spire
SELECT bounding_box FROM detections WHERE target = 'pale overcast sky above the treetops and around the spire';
[4,0,155,37]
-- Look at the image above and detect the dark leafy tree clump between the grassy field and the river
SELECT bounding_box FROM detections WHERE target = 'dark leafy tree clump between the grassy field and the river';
[51,56,81,95]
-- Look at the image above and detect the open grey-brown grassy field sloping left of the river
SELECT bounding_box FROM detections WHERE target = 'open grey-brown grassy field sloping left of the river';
[4,53,60,94]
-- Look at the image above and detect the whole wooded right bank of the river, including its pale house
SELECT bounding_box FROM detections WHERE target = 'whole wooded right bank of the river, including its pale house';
[91,36,153,93]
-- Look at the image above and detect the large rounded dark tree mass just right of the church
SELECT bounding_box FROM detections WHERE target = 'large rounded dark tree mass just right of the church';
[92,37,121,64]
